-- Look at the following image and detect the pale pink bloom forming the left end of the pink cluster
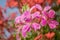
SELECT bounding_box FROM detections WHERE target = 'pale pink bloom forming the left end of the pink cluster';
[15,11,31,23]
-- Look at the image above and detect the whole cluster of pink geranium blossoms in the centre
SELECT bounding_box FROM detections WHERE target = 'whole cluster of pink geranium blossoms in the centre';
[15,4,59,37]
